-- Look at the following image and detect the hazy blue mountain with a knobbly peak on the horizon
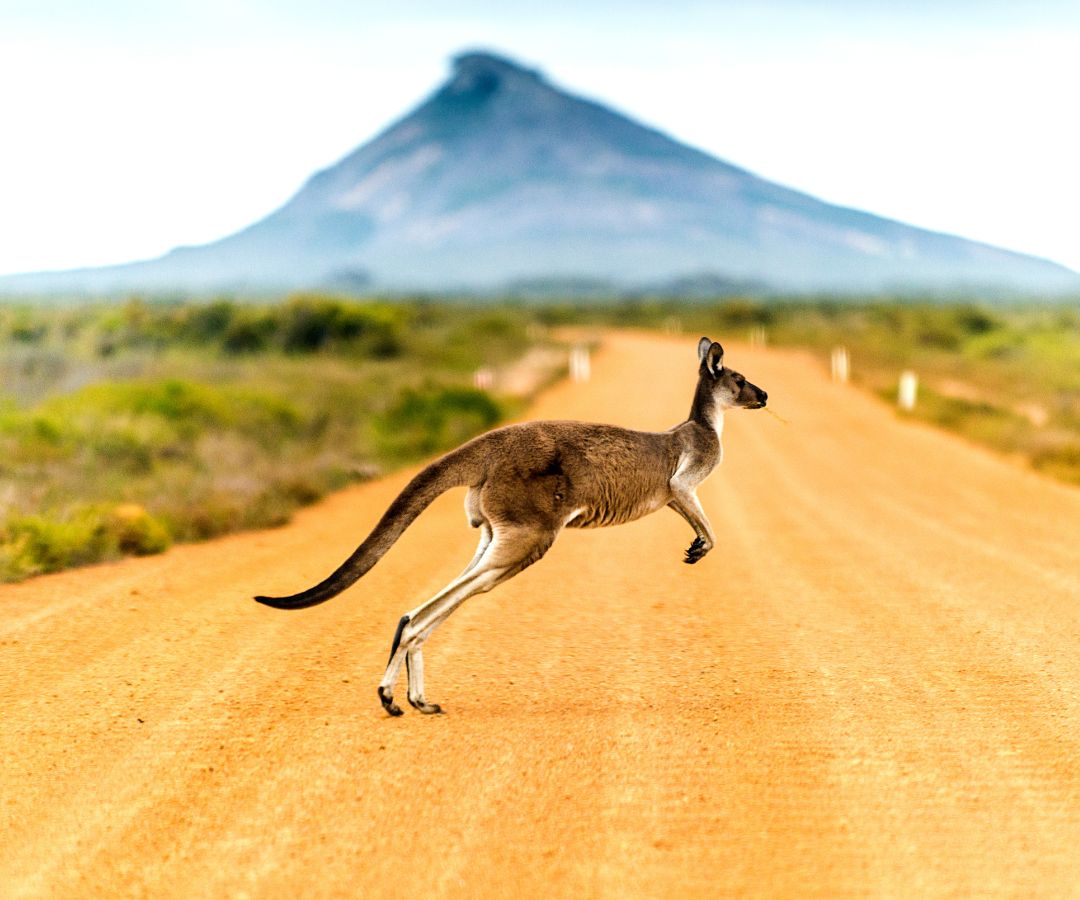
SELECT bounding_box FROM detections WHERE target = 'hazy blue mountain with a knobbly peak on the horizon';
[0,53,1080,293]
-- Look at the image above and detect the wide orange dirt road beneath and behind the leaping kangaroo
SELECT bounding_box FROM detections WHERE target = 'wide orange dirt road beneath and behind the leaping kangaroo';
[0,335,1080,898]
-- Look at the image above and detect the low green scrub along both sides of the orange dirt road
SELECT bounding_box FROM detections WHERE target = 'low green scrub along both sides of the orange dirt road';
[0,295,1080,581]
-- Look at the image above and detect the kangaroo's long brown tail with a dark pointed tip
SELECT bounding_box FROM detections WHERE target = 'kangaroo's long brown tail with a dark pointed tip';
[255,442,481,609]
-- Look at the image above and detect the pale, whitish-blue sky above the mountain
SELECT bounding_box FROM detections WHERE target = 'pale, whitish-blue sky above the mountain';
[0,0,1080,273]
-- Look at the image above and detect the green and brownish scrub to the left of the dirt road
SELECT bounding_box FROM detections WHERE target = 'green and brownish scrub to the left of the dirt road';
[0,296,540,580]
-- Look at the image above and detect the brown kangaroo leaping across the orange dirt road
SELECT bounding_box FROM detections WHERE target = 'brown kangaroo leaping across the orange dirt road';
[255,337,768,715]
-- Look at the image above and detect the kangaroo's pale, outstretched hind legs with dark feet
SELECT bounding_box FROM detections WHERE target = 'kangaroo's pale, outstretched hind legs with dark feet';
[379,527,556,715]
